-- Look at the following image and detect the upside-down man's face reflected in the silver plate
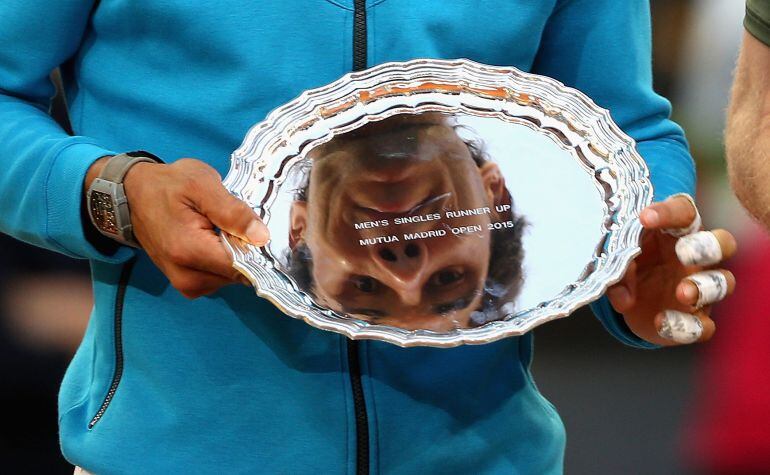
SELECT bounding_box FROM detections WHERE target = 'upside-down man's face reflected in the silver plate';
[290,116,505,331]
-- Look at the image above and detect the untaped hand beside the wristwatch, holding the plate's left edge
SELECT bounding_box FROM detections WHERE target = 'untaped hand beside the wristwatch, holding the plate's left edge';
[115,158,269,298]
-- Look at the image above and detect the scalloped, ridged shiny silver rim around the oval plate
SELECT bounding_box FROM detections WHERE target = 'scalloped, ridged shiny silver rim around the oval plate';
[223,59,652,347]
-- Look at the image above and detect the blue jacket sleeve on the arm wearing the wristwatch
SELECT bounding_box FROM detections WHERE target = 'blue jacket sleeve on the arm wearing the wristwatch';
[0,0,133,262]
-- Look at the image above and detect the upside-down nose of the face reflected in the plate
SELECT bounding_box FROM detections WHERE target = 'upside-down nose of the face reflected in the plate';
[372,241,428,305]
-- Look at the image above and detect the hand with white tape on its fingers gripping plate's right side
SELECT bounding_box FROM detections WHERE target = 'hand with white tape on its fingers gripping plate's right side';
[607,196,736,345]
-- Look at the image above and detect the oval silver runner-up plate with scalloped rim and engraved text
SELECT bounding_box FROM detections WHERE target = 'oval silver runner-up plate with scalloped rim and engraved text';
[224,60,652,347]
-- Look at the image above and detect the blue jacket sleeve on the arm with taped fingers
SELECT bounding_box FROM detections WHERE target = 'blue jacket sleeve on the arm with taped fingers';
[532,0,695,348]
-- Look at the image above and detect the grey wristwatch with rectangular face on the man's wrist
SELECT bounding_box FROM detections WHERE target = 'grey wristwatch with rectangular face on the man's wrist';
[86,151,163,247]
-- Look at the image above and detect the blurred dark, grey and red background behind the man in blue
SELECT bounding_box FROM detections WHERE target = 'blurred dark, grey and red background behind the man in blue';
[0,0,770,475]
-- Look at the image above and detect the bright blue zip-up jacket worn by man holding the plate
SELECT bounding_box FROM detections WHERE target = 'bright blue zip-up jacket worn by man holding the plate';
[0,0,694,474]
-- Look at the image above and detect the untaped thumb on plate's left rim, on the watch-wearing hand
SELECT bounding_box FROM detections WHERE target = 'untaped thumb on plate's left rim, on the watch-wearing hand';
[199,184,270,246]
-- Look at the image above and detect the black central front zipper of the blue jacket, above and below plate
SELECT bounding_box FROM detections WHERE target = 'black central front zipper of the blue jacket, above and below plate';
[347,0,369,475]
